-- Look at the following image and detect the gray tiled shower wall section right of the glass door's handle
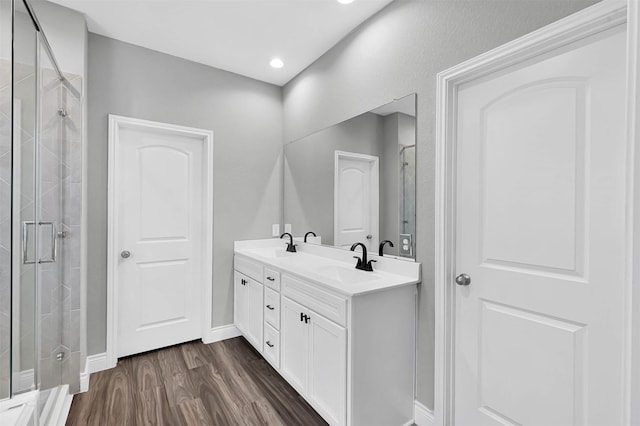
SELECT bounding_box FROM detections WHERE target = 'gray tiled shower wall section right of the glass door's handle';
[39,65,82,393]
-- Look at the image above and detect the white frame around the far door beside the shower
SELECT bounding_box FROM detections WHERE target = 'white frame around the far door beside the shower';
[106,114,213,368]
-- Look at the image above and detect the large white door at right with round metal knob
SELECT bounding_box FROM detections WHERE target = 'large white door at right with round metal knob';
[454,28,626,426]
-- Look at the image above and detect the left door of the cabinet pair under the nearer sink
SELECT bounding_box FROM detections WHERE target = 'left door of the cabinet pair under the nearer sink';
[280,297,309,394]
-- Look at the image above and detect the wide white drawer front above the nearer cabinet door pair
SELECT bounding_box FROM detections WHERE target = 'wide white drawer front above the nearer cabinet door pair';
[282,274,347,326]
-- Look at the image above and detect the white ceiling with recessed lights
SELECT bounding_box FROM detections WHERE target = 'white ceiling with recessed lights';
[51,0,393,86]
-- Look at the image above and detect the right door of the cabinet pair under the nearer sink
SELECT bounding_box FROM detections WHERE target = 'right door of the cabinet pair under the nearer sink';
[307,314,347,425]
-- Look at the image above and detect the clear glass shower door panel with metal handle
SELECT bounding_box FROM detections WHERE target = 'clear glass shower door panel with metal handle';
[11,10,68,400]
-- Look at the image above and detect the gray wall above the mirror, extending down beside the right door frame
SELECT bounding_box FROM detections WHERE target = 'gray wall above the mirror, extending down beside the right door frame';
[283,0,595,407]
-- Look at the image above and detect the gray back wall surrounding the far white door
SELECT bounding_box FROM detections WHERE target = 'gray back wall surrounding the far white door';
[87,34,282,354]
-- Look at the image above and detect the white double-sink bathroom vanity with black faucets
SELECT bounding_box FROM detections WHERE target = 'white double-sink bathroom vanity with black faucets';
[234,239,420,426]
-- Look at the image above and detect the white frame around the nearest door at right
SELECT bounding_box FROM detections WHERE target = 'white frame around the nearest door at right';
[434,0,640,426]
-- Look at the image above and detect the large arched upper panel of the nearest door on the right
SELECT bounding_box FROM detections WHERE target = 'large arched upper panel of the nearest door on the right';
[480,79,587,272]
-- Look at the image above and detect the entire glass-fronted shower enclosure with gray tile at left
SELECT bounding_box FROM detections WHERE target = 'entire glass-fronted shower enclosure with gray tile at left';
[0,0,82,423]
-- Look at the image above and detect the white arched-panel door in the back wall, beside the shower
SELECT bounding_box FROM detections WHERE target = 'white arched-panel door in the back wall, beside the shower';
[113,120,210,357]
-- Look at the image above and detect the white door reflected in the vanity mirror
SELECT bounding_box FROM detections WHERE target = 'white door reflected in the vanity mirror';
[333,151,379,249]
